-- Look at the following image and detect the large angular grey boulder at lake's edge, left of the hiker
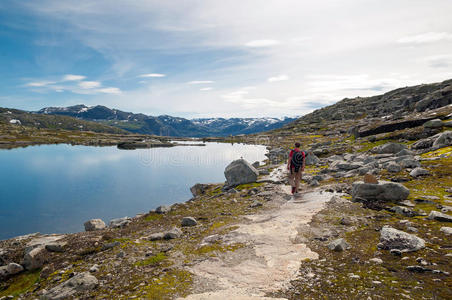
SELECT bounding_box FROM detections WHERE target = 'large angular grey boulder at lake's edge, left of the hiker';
[224,158,259,186]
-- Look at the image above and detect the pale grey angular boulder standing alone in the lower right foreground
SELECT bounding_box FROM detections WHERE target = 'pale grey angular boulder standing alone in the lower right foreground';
[378,226,425,252]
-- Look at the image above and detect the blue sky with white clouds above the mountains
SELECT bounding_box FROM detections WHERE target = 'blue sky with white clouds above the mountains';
[0,0,452,118]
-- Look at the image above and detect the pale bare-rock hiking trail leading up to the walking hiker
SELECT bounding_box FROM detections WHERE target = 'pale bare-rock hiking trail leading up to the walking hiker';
[178,167,340,300]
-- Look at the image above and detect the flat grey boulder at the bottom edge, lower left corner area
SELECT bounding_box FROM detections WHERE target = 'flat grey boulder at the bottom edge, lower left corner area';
[41,272,99,300]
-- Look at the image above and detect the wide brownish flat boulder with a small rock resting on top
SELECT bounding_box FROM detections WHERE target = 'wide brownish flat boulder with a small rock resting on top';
[352,181,410,201]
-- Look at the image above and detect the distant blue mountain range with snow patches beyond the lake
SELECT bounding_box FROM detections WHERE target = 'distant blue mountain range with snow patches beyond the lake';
[36,104,296,137]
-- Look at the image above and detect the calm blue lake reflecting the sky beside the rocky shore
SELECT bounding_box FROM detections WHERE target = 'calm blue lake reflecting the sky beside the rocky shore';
[0,143,266,239]
